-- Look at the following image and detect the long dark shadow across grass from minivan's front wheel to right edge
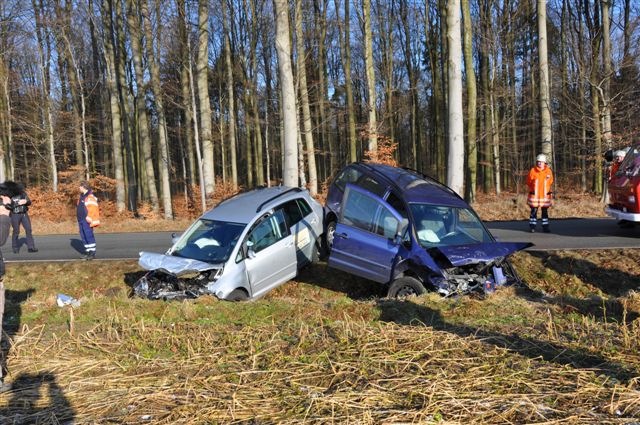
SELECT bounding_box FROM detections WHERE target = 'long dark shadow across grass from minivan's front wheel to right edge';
[378,299,637,382]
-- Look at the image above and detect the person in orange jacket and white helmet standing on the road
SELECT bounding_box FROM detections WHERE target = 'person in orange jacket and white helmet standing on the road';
[527,154,553,233]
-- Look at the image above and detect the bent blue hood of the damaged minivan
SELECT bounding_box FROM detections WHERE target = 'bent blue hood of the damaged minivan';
[429,242,533,267]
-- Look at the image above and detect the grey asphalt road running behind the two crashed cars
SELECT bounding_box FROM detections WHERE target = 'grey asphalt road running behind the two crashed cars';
[2,218,640,262]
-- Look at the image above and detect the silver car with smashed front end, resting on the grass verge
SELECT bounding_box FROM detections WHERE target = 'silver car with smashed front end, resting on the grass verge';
[133,186,324,301]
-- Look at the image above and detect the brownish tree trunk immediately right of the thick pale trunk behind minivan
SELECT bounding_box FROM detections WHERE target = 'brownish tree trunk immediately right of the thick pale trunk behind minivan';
[461,0,478,203]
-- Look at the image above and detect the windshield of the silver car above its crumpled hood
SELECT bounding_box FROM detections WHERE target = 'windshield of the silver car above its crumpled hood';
[171,219,246,263]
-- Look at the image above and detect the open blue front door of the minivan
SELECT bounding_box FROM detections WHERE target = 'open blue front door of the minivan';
[329,185,403,283]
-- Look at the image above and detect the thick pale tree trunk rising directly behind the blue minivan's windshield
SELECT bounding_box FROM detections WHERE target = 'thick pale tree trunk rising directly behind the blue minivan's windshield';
[447,0,464,195]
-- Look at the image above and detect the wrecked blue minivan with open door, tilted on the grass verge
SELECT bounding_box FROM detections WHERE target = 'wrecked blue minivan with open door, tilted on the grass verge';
[325,163,532,297]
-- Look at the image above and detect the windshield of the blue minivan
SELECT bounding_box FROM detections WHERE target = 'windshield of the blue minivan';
[410,203,493,248]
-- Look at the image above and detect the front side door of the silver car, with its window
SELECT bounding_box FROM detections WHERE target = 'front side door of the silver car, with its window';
[244,210,297,297]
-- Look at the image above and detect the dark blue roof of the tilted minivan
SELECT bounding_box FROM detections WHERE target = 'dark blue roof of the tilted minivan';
[357,163,469,208]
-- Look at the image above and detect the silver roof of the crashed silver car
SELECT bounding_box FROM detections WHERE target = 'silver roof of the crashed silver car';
[201,186,306,224]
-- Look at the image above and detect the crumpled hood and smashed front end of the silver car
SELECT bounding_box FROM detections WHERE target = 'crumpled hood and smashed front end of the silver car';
[133,252,222,300]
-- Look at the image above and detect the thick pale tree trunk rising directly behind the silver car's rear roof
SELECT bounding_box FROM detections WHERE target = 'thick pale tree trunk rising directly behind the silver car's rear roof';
[274,0,298,187]
